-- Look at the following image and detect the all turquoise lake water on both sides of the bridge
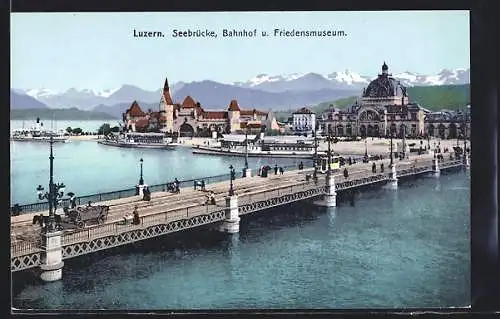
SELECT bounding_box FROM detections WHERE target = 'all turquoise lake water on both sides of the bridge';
[11,122,470,310]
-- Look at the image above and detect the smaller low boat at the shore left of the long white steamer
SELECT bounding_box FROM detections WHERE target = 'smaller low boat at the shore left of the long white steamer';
[97,132,178,149]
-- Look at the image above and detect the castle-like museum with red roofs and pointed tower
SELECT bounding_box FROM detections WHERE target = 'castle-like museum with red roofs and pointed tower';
[123,79,280,136]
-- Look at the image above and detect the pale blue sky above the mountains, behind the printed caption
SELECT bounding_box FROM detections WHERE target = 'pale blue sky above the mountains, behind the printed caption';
[10,11,470,91]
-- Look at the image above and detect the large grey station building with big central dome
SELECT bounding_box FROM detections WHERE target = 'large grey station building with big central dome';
[318,62,470,138]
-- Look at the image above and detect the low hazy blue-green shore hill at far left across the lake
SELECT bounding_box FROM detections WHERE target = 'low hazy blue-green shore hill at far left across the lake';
[10,108,117,120]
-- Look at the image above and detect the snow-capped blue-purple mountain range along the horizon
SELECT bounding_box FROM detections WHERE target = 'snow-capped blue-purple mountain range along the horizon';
[11,69,470,117]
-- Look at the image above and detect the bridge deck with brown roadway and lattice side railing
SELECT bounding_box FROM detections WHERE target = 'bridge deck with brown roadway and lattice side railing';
[11,155,460,271]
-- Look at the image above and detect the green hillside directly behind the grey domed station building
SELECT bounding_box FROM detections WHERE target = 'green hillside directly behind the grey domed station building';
[312,84,470,114]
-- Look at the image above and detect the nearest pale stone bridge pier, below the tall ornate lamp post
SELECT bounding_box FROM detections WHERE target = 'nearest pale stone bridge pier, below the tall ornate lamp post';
[40,231,64,281]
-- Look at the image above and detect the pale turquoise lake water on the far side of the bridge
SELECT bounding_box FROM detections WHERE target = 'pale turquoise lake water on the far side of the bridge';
[10,140,307,204]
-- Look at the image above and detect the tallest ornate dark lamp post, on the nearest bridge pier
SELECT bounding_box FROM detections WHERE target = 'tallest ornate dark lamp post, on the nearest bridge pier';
[36,136,66,232]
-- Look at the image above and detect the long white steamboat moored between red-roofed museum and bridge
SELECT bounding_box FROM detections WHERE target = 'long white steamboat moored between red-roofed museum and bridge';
[192,134,314,159]
